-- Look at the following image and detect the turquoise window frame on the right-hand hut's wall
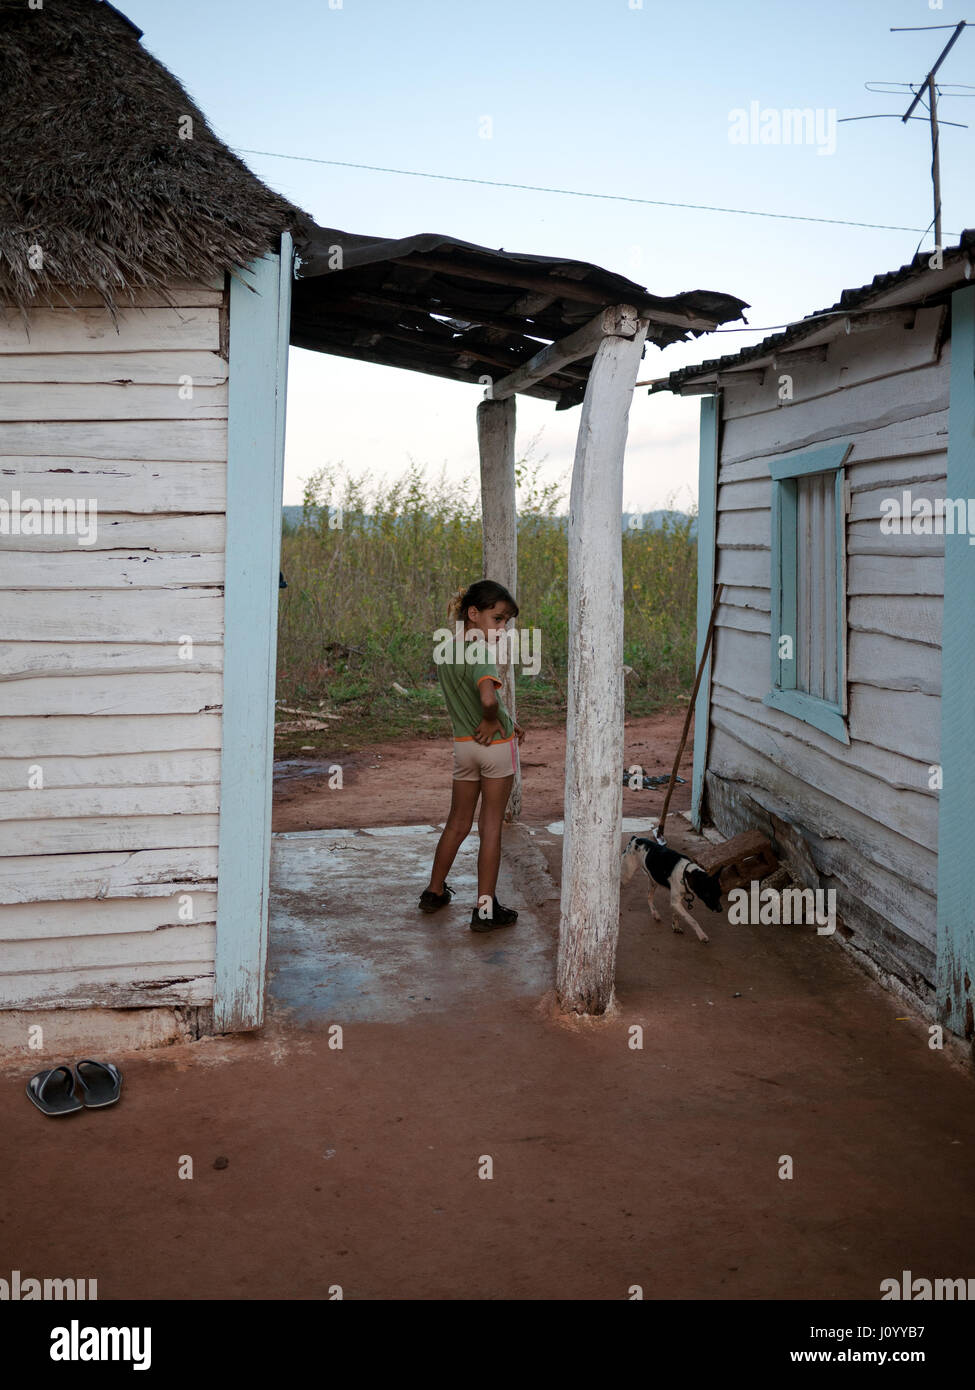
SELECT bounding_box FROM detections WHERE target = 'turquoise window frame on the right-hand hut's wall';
[762,441,853,744]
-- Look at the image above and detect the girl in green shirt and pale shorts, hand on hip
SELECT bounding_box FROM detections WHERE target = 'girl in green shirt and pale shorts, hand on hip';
[420,580,524,931]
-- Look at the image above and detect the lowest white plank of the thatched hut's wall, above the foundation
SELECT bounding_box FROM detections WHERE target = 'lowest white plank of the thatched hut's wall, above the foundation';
[0,960,213,1009]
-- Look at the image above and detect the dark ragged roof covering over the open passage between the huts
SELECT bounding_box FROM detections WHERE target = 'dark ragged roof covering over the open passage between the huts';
[291,222,748,410]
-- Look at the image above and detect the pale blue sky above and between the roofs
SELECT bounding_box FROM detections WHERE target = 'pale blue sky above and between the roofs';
[125,0,975,509]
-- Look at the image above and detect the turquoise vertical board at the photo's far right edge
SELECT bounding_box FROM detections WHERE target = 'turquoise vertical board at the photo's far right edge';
[937,285,975,1037]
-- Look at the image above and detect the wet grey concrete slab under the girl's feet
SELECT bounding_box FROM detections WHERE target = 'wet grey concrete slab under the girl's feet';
[268,824,559,1024]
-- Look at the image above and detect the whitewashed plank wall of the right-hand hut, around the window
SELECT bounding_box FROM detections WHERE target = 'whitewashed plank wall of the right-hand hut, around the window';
[708,309,950,994]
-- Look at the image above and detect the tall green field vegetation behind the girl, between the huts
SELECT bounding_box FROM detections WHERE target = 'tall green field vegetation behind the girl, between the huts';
[275,460,697,755]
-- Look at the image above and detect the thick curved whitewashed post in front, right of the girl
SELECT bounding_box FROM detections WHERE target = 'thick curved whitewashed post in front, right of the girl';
[556,306,648,1013]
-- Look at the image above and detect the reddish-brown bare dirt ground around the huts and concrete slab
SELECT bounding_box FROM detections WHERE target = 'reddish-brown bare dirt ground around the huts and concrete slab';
[0,717,975,1301]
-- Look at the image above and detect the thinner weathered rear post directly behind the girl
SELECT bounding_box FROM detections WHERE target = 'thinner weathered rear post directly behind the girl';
[477,395,522,821]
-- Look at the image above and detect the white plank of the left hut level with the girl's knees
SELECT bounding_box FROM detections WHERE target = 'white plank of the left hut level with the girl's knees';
[0,816,218,872]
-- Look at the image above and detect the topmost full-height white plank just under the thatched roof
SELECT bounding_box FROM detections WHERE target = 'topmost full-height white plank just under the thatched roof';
[0,304,220,354]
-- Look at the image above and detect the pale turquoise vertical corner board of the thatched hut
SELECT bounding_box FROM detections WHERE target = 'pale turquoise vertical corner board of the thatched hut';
[213,232,292,1033]
